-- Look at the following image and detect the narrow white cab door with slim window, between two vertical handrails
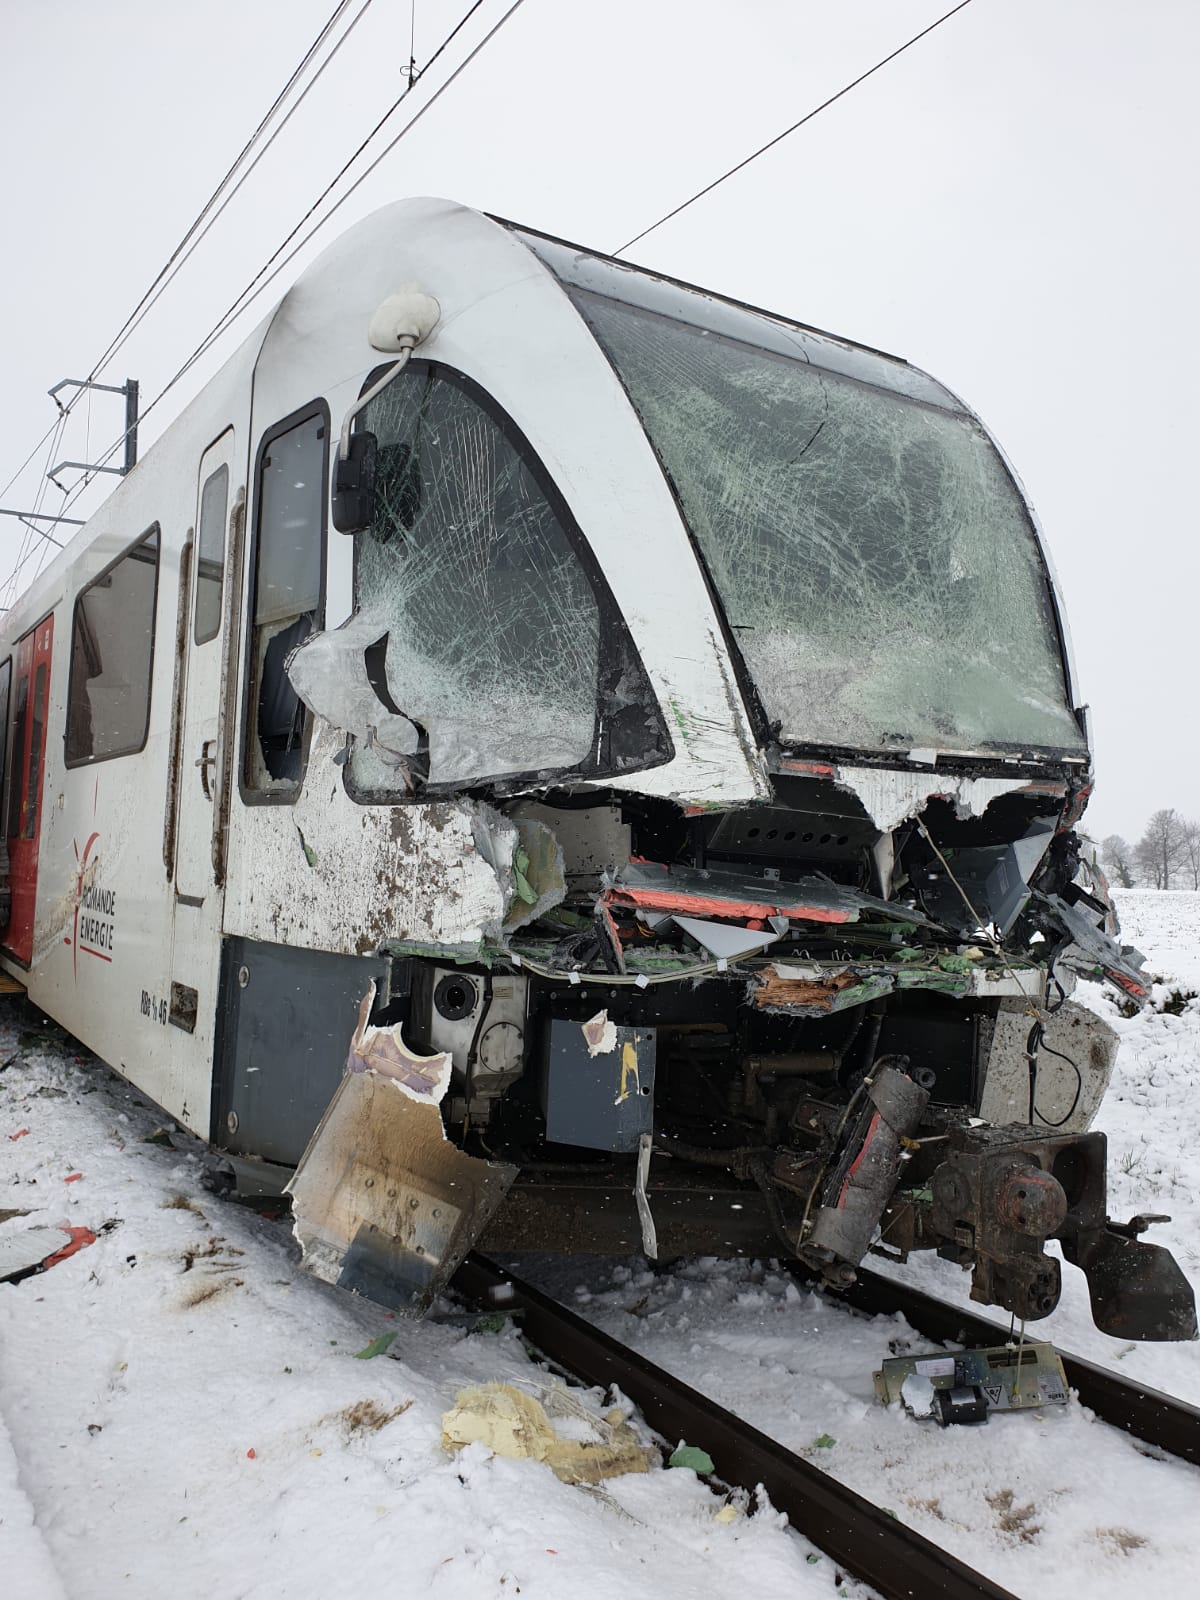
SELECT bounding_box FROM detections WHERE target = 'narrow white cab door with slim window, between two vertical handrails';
[174,427,237,907]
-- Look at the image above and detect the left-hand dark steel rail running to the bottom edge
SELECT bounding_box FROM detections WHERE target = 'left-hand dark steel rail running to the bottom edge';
[453,1253,1014,1600]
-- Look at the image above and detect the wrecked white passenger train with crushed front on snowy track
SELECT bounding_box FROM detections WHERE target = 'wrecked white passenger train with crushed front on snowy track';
[0,200,1197,1339]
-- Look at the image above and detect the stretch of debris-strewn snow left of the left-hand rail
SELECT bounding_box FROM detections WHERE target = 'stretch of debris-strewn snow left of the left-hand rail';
[0,1013,861,1600]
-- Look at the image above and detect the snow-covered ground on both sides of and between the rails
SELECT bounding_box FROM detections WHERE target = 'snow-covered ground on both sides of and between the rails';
[0,893,1200,1600]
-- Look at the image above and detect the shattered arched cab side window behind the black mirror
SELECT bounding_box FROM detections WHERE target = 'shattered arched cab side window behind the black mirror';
[349,362,602,795]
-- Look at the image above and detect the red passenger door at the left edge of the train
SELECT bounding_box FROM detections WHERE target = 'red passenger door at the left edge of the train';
[3,616,54,966]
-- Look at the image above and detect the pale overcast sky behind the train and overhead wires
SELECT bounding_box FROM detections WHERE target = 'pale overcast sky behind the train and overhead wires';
[0,0,1200,837]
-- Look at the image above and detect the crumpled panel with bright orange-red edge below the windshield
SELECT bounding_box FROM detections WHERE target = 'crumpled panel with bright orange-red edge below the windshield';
[603,861,931,926]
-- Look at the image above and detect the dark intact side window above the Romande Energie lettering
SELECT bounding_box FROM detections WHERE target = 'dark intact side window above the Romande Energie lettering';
[65,526,160,771]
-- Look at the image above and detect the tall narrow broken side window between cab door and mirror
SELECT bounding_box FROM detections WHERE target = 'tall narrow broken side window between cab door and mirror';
[245,408,328,797]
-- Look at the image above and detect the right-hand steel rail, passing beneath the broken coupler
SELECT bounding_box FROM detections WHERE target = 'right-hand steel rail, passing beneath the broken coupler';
[800,1261,1200,1466]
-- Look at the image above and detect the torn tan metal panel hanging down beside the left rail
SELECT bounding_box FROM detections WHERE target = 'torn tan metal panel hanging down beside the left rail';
[288,1070,517,1314]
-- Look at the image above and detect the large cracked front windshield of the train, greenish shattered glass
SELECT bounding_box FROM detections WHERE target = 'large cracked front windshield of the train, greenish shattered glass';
[569,286,1085,754]
